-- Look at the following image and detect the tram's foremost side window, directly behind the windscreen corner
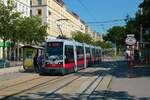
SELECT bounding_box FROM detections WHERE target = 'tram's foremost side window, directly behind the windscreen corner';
[65,45,74,63]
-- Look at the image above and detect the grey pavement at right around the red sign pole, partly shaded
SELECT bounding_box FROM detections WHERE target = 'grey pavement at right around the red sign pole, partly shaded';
[106,63,150,100]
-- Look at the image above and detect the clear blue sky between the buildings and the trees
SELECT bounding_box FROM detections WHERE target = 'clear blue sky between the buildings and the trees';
[64,0,144,34]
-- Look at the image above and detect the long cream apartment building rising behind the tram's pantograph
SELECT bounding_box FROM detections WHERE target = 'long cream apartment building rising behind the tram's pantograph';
[31,0,85,37]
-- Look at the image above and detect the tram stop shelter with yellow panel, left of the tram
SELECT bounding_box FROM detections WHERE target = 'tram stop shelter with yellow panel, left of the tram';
[22,45,44,71]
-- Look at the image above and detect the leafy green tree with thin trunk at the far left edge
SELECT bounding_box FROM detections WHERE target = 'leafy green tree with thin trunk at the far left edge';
[0,0,20,59]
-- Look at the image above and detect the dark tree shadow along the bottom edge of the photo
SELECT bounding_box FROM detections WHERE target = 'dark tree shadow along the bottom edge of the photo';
[6,91,150,100]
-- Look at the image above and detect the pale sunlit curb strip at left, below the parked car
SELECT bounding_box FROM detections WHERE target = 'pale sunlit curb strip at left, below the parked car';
[0,66,24,75]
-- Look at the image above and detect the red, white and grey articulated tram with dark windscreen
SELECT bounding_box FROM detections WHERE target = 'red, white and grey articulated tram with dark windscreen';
[40,39,102,75]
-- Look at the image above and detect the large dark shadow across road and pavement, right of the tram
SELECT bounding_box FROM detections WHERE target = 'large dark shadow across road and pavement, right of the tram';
[89,60,150,78]
